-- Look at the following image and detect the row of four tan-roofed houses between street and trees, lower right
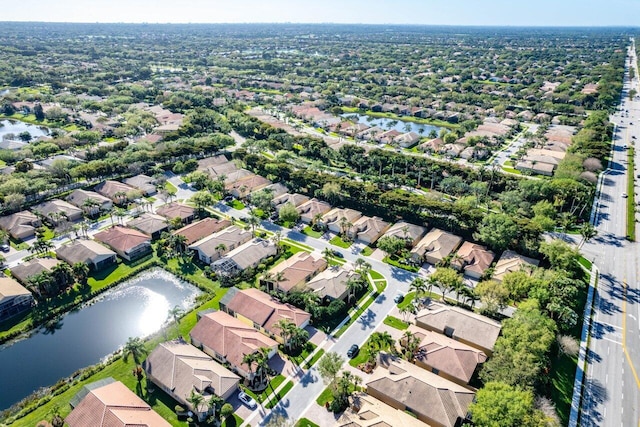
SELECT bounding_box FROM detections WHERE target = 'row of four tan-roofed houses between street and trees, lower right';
[336,303,501,427]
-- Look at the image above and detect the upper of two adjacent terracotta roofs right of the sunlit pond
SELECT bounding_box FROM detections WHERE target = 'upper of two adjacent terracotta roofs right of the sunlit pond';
[227,288,311,334]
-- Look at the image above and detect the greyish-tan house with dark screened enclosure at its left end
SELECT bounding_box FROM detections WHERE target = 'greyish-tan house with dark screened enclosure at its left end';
[211,239,278,276]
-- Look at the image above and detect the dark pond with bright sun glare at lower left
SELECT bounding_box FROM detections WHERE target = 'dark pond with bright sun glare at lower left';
[0,269,201,410]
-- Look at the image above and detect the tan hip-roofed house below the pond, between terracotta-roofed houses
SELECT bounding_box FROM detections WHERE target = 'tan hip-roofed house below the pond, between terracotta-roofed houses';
[142,340,240,421]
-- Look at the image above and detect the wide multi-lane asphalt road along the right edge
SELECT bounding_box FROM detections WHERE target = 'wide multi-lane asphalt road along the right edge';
[580,41,640,427]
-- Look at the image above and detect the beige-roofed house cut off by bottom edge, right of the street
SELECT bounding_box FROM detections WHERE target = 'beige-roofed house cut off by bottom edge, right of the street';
[334,392,428,427]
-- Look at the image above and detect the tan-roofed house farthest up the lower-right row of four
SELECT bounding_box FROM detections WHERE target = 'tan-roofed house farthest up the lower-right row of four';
[416,302,502,356]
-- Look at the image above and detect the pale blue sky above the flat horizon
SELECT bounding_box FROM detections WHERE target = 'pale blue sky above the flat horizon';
[0,0,640,27]
